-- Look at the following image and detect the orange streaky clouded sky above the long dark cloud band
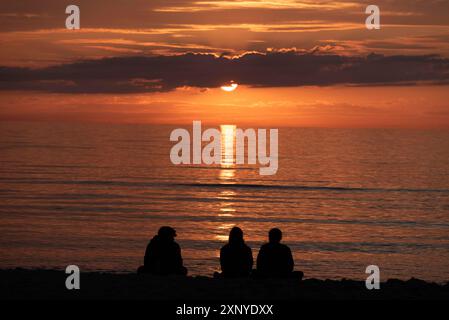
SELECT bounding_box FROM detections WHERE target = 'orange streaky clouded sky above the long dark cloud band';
[0,0,449,67]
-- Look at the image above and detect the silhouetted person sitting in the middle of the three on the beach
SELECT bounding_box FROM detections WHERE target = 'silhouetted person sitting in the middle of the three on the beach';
[215,227,253,278]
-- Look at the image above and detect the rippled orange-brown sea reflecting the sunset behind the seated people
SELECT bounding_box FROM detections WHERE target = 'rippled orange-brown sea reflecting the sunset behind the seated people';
[0,122,449,282]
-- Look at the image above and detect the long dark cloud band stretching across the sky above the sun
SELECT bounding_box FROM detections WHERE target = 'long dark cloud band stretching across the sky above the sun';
[0,50,449,93]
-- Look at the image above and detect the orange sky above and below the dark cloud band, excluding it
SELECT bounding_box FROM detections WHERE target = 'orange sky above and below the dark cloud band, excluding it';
[0,0,449,128]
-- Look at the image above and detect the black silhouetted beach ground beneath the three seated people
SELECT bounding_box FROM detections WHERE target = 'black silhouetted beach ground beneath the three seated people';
[0,269,449,301]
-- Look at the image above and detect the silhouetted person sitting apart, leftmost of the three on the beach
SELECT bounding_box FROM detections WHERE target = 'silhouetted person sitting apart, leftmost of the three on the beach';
[137,226,187,275]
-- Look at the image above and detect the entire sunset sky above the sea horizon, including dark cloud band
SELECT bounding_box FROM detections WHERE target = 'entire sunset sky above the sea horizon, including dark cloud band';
[0,0,449,128]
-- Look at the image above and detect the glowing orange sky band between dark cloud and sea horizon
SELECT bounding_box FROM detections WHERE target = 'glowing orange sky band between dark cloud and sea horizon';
[1,86,449,128]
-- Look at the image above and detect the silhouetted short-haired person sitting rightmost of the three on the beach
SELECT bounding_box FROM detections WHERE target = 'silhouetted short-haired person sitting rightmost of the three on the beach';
[256,228,303,279]
